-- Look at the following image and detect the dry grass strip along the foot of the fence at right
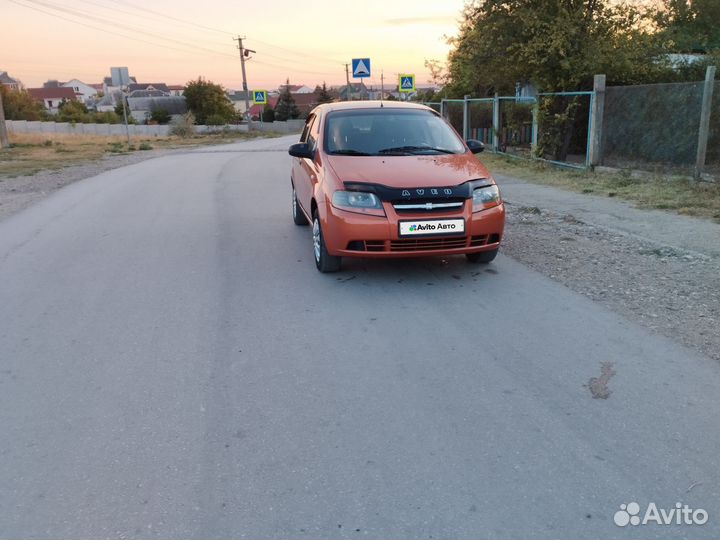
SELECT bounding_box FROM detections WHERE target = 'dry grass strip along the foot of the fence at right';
[481,153,720,223]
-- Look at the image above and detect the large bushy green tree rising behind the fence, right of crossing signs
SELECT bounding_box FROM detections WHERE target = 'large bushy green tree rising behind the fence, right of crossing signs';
[448,0,665,96]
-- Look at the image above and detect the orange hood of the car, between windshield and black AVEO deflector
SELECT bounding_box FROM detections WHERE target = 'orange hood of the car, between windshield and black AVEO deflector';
[326,152,491,188]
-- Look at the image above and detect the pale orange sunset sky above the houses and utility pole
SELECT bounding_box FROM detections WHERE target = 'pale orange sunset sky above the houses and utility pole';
[0,0,464,89]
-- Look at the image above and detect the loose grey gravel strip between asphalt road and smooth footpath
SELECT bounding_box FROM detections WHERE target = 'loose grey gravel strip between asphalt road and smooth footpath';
[502,199,720,360]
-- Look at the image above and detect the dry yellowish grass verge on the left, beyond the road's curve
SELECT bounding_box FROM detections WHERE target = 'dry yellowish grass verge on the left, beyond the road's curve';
[0,132,279,178]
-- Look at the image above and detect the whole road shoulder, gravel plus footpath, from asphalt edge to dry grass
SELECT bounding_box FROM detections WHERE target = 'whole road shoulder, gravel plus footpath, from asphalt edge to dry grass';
[496,174,720,360]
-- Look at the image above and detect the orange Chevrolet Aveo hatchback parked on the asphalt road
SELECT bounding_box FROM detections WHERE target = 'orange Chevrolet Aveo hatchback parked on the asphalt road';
[289,101,505,272]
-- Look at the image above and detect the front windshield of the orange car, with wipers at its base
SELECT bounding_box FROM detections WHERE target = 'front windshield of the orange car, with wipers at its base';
[325,108,465,156]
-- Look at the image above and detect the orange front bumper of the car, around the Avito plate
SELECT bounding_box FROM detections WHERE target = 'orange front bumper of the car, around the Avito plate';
[323,200,505,258]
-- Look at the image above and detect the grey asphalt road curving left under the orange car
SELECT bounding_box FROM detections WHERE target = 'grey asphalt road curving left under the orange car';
[0,137,720,540]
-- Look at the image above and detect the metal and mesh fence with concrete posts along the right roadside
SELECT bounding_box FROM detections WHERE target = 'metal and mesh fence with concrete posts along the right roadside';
[436,67,720,179]
